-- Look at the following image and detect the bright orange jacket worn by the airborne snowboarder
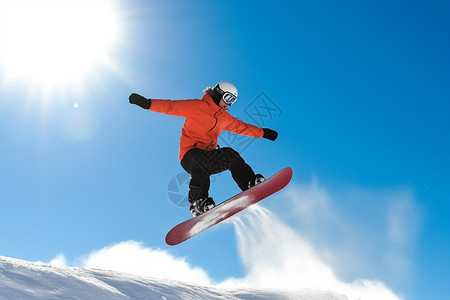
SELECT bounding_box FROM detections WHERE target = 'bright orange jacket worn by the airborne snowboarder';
[149,94,264,161]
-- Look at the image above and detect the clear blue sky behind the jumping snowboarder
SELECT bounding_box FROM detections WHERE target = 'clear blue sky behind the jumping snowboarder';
[0,0,450,299]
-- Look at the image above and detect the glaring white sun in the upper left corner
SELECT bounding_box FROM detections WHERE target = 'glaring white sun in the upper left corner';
[0,0,121,92]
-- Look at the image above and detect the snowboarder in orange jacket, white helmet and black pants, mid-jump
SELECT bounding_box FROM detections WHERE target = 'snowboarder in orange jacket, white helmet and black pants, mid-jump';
[129,81,278,217]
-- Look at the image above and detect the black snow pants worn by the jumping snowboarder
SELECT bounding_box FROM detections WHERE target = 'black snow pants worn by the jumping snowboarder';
[181,147,255,202]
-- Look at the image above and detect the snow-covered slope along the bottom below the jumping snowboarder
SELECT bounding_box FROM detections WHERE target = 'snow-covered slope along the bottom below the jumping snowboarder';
[0,256,347,300]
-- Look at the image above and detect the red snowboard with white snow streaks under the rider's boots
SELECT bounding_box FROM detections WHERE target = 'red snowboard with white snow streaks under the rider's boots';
[166,167,293,246]
